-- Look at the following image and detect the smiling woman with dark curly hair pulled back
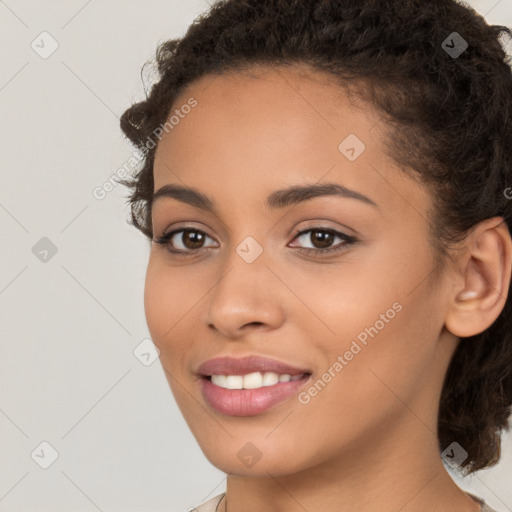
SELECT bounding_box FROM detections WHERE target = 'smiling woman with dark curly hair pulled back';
[117,0,512,512]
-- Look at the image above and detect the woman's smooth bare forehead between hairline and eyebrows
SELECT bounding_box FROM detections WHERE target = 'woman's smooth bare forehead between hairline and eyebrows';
[154,67,432,218]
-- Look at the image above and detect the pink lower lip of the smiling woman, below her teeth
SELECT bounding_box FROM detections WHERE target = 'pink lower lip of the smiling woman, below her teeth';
[200,374,311,416]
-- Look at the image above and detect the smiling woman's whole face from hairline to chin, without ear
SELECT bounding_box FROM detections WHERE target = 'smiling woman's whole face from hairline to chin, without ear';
[144,64,460,475]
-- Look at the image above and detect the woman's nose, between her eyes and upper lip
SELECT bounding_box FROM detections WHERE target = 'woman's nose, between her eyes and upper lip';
[203,251,286,340]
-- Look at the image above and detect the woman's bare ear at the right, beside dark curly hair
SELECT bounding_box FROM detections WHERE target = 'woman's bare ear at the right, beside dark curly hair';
[445,217,512,337]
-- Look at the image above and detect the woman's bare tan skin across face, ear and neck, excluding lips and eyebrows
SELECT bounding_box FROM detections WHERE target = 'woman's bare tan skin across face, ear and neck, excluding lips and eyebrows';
[144,67,512,512]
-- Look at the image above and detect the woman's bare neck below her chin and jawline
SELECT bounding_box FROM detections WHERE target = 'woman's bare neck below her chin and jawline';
[218,425,481,512]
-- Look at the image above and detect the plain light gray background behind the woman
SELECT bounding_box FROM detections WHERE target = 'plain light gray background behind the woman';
[0,0,512,512]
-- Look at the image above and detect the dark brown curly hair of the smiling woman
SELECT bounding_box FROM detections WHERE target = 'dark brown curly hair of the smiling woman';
[120,0,512,475]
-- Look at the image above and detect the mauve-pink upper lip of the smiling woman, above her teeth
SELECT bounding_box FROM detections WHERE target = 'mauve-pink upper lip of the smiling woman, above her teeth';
[197,355,311,376]
